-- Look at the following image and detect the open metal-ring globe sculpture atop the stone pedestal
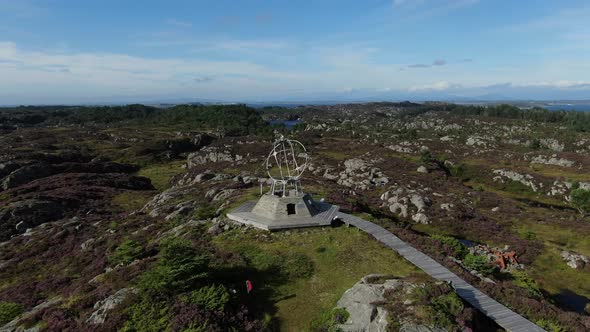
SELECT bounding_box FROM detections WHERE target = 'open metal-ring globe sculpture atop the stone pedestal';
[265,136,310,196]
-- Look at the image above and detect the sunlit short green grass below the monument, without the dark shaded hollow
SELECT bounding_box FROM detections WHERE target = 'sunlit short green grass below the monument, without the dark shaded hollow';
[214,227,418,331]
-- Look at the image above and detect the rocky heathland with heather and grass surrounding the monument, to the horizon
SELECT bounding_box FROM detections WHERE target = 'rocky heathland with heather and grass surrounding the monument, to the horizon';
[0,102,590,331]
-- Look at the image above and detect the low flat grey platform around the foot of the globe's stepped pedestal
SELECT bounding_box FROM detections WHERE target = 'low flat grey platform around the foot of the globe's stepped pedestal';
[227,201,340,231]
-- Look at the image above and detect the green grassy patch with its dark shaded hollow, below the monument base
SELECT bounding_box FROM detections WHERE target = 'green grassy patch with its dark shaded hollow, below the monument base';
[214,227,417,331]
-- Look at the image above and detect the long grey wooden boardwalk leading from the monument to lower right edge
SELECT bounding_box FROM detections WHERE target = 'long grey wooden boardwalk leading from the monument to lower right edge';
[337,212,545,332]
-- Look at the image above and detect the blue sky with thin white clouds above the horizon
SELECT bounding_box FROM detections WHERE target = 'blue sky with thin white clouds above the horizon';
[0,0,590,104]
